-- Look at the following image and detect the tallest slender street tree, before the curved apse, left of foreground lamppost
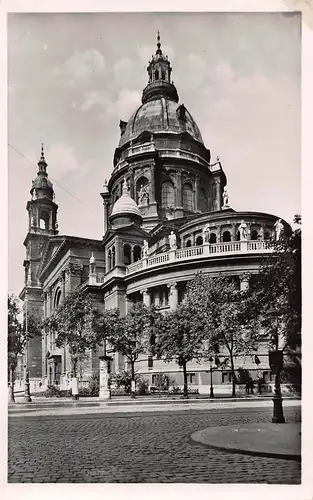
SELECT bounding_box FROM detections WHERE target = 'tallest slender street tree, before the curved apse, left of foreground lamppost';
[187,273,256,397]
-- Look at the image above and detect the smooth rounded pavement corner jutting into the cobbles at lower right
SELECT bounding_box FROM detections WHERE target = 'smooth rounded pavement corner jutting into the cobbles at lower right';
[191,423,301,461]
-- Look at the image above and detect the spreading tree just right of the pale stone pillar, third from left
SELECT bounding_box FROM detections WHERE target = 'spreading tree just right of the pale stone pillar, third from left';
[97,304,158,394]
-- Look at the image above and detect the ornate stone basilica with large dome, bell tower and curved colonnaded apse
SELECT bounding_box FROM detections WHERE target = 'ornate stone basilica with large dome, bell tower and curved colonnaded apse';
[20,37,290,393]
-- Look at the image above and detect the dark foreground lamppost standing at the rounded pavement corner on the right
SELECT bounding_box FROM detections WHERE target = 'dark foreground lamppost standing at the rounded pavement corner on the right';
[267,307,285,424]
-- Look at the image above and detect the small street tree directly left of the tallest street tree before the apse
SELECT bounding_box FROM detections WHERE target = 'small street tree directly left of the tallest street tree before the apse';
[154,301,204,397]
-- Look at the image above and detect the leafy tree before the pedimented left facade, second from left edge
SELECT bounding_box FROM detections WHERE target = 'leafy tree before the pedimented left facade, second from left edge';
[44,289,94,377]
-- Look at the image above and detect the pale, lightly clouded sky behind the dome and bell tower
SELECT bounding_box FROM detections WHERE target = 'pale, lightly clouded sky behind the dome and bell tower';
[8,12,301,294]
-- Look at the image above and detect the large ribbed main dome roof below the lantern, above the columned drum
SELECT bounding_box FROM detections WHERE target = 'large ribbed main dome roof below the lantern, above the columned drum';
[119,97,203,147]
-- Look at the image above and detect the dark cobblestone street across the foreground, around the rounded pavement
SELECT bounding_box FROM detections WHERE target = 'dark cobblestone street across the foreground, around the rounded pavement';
[8,408,301,484]
